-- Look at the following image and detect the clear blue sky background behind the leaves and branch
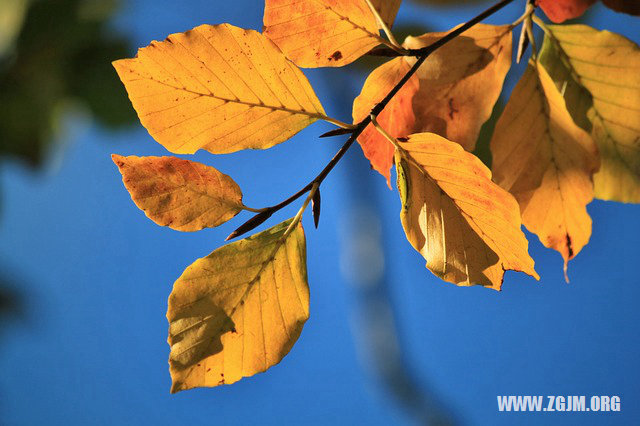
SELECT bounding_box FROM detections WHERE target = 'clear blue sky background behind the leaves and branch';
[0,0,640,425]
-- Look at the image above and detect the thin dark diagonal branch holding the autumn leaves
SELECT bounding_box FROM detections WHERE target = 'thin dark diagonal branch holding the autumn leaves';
[227,0,513,240]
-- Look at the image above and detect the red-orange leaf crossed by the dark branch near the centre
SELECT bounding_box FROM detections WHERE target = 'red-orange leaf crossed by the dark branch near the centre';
[353,58,418,183]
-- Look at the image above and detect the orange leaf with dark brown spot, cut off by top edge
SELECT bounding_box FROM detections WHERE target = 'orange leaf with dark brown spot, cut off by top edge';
[264,0,384,68]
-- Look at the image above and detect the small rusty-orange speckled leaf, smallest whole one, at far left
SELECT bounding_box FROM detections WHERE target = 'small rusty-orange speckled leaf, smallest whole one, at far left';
[111,154,243,231]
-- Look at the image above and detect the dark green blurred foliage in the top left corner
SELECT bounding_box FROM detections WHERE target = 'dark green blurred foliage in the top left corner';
[0,0,136,167]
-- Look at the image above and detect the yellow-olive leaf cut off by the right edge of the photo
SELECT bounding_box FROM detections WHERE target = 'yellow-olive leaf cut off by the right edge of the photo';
[543,25,640,203]
